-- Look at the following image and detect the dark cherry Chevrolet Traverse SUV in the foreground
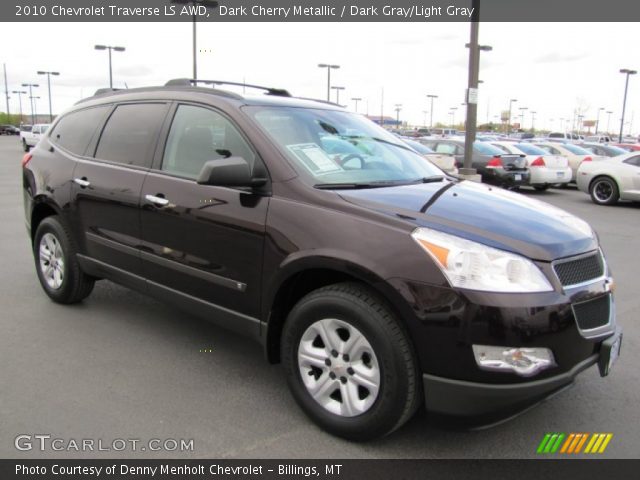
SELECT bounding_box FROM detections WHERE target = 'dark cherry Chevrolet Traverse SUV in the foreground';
[23,80,621,440]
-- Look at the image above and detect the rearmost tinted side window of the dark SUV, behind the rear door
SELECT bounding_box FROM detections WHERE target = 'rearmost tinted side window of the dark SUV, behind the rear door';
[51,105,111,155]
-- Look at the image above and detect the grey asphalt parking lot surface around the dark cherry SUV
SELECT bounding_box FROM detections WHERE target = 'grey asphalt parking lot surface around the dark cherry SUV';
[0,137,640,459]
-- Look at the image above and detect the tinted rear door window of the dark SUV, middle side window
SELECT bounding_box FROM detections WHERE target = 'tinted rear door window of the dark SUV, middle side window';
[96,103,166,167]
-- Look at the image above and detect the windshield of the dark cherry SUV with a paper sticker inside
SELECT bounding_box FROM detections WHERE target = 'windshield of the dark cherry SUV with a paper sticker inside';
[246,107,443,187]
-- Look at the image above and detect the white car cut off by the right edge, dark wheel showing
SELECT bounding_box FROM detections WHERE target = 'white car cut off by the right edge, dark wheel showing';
[577,152,640,205]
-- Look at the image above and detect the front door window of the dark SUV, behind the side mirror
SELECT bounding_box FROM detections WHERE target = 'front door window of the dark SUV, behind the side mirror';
[162,105,255,179]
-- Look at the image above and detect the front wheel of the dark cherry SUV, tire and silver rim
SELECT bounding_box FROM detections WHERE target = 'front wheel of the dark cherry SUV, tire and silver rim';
[281,283,422,441]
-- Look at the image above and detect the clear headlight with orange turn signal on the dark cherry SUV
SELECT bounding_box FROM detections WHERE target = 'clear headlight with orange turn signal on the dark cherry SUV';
[411,228,553,293]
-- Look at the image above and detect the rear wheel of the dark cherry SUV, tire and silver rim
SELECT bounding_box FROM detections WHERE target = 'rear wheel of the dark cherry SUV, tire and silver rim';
[33,215,95,304]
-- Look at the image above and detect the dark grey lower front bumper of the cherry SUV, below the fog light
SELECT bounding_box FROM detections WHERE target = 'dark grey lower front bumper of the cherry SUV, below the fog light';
[422,327,622,425]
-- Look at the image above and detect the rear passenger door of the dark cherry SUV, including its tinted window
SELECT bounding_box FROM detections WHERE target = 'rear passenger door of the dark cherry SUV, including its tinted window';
[71,102,168,275]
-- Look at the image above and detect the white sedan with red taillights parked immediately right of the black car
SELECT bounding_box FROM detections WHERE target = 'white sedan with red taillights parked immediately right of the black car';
[487,142,571,191]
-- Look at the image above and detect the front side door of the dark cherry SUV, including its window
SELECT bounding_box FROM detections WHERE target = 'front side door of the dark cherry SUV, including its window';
[141,103,269,320]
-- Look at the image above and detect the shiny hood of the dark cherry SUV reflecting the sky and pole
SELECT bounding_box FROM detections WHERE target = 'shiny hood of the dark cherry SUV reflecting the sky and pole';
[339,181,598,262]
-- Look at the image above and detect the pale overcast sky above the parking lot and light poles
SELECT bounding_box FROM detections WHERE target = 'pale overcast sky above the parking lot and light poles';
[0,22,640,133]
